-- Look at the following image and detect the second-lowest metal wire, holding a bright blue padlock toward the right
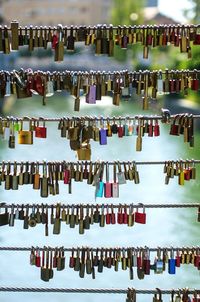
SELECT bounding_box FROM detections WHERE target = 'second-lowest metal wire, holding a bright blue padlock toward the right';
[0,246,200,252]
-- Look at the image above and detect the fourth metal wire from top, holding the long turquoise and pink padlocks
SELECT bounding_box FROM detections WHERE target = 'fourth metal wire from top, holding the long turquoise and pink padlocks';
[0,159,200,166]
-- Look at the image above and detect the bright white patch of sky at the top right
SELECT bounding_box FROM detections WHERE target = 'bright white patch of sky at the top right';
[158,0,191,23]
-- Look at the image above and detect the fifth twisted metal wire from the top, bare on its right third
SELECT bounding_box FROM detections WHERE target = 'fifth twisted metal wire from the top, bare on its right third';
[0,201,200,209]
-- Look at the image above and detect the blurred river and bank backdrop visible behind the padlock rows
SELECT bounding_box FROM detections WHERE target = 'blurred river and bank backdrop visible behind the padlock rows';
[0,0,200,302]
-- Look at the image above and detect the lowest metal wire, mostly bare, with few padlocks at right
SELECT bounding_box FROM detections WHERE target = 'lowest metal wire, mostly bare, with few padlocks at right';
[0,287,200,295]
